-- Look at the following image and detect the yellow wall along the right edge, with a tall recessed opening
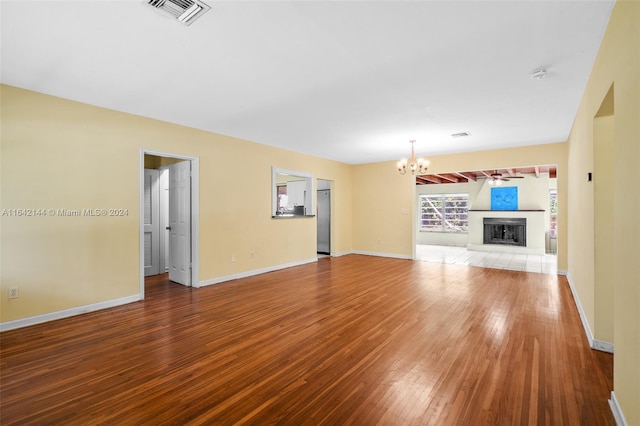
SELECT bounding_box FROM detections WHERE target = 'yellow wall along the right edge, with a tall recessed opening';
[568,1,640,425]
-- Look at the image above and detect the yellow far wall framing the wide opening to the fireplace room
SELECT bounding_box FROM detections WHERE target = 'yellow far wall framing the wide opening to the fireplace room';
[353,143,567,270]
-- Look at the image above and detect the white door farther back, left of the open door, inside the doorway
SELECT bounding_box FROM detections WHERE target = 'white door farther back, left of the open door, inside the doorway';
[144,169,160,277]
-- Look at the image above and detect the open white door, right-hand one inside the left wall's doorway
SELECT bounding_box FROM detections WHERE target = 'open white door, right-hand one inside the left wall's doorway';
[169,161,191,286]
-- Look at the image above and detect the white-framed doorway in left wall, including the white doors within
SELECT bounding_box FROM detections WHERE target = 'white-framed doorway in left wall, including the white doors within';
[139,149,199,298]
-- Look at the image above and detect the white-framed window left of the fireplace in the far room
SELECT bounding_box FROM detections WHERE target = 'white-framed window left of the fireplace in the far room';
[419,194,469,232]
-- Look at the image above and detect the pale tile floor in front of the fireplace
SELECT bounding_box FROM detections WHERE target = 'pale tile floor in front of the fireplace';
[416,244,558,274]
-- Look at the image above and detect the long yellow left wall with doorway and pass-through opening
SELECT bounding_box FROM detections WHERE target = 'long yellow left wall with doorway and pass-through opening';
[0,86,352,322]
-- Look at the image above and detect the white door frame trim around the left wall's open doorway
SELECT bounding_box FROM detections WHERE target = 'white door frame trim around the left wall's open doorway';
[138,148,200,300]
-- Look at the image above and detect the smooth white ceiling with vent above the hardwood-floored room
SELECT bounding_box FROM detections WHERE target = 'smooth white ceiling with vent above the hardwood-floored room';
[0,0,614,164]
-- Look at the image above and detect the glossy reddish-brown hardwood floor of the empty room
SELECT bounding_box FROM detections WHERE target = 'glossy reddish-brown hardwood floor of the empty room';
[0,255,615,425]
